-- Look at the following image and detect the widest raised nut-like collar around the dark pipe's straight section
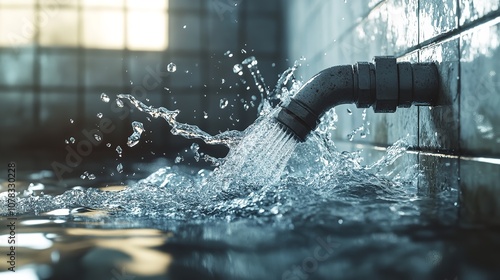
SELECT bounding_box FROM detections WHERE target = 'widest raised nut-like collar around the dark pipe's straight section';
[373,56,399,113]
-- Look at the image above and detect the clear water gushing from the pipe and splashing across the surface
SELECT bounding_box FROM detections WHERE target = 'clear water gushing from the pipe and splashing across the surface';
[0,55,426,226]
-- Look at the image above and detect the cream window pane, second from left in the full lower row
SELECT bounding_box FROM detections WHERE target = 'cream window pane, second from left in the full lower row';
[40,9,78,46]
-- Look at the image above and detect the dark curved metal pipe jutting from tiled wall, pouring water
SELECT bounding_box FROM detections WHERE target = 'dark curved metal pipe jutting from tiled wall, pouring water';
[276,56,439,141]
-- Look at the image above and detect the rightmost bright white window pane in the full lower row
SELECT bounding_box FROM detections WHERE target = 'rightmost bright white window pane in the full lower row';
[127,11,168,50]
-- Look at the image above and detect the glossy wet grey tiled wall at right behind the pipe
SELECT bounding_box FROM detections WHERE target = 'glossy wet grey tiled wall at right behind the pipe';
[285,0,500,222]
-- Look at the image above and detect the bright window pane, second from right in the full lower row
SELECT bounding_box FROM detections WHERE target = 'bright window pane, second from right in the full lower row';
[83,9,124,49]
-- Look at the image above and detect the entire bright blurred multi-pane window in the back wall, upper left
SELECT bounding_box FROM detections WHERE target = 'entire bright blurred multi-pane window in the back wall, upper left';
[0,0,168,51]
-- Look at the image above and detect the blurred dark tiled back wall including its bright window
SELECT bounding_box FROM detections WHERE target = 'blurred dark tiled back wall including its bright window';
[0,0,288,172]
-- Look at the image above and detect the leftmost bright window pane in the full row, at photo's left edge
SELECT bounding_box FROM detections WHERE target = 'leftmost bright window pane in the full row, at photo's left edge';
[0,9,36,47]
